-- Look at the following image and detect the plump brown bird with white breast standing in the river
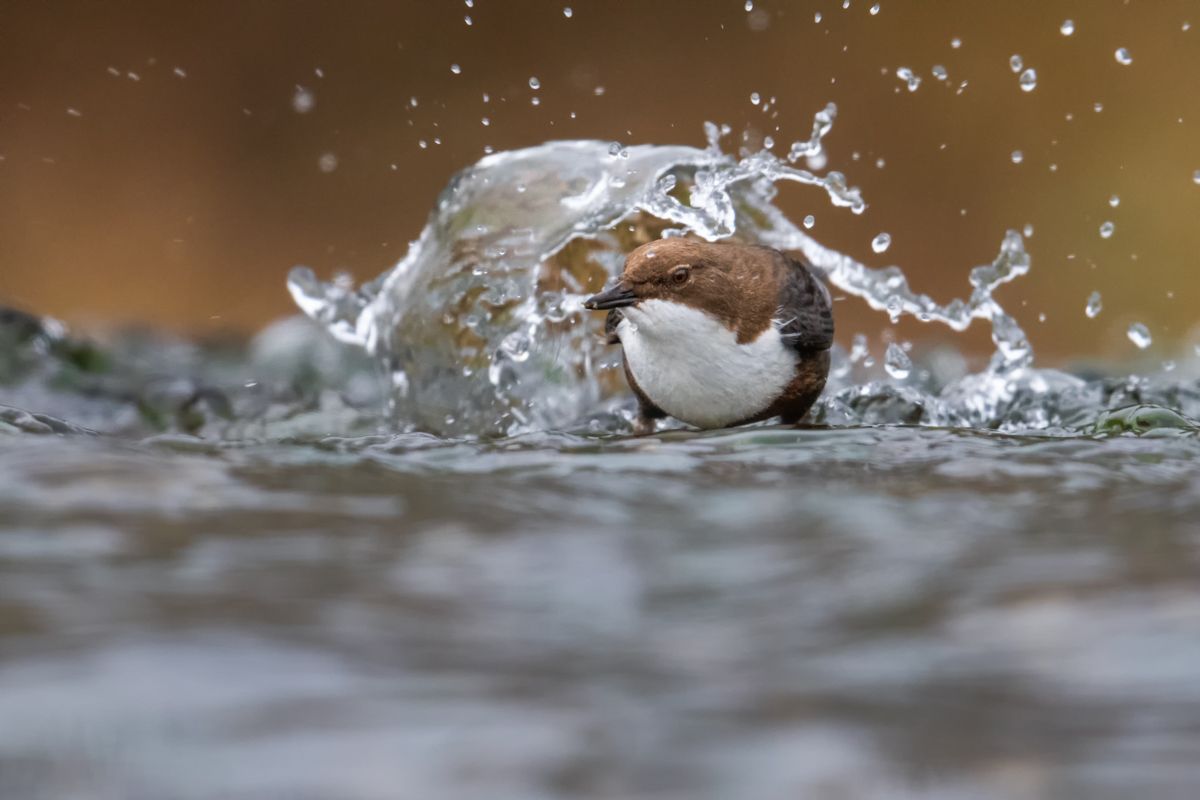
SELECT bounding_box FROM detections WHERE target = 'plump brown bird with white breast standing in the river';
[583,239,833,433]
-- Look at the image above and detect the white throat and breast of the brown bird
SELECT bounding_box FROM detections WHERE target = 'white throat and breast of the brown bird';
[617,300,796,428]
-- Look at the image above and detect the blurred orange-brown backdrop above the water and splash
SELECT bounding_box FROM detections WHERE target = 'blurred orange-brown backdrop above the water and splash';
[0,0,1200,363]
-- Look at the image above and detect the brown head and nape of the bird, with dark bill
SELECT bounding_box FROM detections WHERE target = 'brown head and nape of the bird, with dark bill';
[583,239,785,342]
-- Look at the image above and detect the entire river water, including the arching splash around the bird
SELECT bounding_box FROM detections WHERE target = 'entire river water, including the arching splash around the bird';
[7,120,1200,800]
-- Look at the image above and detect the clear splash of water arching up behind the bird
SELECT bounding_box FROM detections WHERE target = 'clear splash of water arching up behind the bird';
[288,104,1123,437]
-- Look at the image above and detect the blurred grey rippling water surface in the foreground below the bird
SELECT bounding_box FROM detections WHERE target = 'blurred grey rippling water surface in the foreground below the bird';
[0,427,1200,799]
